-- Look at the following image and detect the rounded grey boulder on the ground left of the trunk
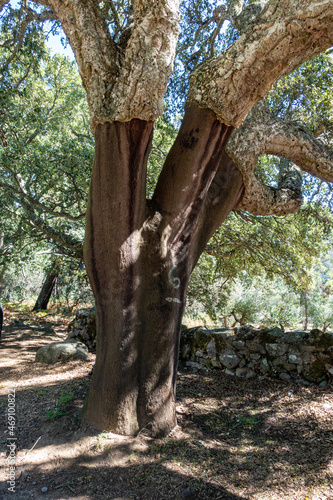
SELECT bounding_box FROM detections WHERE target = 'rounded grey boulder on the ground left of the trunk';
[35,340,89,364]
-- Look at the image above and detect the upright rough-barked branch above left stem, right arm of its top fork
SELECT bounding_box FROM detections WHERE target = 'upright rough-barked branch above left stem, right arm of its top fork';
[103,0,179,121]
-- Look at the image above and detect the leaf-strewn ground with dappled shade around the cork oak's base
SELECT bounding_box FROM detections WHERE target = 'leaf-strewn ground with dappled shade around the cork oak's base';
[0,302,333,500]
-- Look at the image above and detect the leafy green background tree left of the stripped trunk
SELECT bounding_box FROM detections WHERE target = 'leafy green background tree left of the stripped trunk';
[0,13,93,308]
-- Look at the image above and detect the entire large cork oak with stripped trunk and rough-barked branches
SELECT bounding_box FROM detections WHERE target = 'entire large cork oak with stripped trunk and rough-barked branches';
[1,0,333,434]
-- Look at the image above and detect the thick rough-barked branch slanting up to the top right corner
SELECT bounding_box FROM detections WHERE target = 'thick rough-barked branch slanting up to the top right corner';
[187,0,333,127]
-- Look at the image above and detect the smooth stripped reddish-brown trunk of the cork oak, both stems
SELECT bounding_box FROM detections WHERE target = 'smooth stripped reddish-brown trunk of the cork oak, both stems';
[84,109,241,436]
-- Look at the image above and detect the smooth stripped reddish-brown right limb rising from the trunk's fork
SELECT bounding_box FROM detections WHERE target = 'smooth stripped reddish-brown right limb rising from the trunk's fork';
[153,106,232,244]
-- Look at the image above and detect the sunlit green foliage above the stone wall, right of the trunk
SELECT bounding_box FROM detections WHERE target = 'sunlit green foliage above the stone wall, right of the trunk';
[188,205,332,323]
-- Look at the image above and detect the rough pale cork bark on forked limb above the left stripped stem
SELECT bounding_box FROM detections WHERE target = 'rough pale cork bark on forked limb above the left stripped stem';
[36,0,179,129]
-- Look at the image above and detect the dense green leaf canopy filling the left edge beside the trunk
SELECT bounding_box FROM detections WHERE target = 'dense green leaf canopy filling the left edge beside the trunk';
[0,25,93,255]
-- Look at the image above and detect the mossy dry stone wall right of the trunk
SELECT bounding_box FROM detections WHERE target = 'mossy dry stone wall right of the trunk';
[180,325,333,386]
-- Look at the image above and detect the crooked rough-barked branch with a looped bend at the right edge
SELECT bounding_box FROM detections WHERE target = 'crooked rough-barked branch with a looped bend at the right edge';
[227,102,333,215]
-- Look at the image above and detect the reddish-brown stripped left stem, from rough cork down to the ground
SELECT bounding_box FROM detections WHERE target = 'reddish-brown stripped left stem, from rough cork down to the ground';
[84,120,153,434]
